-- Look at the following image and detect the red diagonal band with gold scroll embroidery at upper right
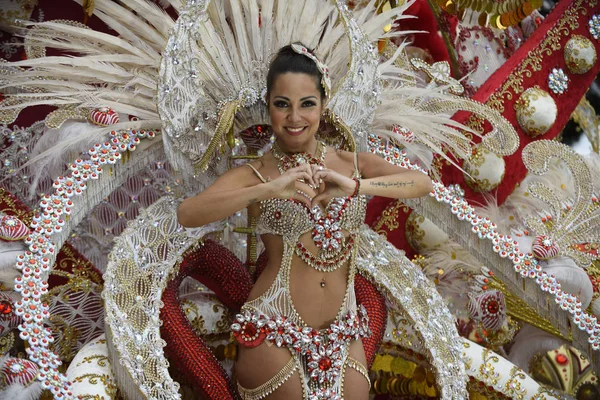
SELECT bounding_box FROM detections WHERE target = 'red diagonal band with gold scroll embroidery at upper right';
[442,0,600,204]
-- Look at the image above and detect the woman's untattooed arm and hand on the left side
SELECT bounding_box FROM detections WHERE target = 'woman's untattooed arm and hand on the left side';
[177,161,313,227]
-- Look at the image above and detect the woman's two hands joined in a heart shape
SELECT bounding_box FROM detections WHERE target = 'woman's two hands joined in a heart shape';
[269,164,356,207]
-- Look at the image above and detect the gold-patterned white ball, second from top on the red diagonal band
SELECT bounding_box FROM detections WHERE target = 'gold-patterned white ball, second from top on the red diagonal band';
[515,87,558,138]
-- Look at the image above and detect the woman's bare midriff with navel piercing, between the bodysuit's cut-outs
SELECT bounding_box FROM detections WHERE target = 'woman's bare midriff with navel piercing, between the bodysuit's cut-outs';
[248,233,349,329]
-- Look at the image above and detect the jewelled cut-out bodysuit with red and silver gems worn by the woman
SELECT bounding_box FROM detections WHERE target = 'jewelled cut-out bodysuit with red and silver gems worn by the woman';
[232,153,369,399]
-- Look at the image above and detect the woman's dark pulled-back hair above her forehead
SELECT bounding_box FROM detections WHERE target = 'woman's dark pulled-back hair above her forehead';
[267,45,326,99]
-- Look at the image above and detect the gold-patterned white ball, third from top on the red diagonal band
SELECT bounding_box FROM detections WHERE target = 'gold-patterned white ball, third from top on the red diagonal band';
[463,146,506,192]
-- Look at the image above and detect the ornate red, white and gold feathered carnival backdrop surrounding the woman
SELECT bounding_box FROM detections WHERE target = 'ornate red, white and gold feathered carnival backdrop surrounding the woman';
[0,0,600,400]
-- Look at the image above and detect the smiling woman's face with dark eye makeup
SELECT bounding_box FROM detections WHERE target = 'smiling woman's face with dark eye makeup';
[269,72,323,152]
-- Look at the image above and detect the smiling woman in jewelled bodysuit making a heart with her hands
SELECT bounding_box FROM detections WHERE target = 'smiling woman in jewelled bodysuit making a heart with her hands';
[178,44,432,399]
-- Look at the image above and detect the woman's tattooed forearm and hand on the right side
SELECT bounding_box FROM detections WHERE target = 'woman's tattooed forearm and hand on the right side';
[312,153,433,205]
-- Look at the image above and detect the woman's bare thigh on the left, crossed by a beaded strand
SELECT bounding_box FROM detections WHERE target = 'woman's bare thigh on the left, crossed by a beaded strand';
[235,342,302,400]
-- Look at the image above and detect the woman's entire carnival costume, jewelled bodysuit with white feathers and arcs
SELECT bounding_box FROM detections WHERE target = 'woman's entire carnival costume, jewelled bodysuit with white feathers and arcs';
[0,0,600,400]
